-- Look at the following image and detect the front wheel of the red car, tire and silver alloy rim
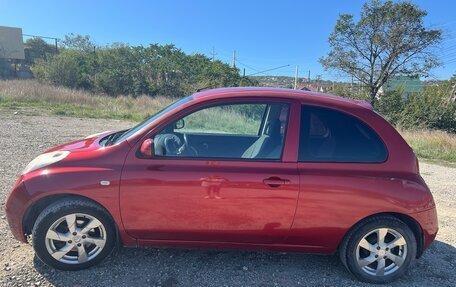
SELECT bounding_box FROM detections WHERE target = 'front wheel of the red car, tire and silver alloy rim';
[32,198,117,271]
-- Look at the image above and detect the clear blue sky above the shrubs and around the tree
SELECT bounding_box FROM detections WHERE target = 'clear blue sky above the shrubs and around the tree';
[0,0,456,81]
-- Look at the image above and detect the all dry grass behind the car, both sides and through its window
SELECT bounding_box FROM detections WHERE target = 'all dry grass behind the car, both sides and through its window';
[0,80,456,163]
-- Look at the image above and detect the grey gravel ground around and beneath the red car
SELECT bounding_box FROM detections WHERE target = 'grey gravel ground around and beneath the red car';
[0,108,456,286]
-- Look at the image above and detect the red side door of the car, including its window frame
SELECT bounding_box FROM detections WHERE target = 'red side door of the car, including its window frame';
[120,98,299,243]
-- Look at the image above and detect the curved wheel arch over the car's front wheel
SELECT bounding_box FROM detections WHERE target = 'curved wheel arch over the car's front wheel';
[22,193,120,241]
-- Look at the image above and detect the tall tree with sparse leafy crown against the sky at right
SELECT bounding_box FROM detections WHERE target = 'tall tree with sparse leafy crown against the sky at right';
[320,0,442,105]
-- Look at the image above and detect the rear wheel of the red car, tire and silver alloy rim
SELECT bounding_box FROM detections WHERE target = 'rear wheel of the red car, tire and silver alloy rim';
[339,216,417,284]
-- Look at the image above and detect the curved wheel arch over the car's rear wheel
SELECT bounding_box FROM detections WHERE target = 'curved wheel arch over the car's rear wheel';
[337,212,424,258]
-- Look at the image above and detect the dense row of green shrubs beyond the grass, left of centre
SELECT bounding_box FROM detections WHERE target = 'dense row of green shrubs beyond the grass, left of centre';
[32,35,251,97]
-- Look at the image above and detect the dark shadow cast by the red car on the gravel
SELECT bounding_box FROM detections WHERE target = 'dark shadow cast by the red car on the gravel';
[34,241,456,287]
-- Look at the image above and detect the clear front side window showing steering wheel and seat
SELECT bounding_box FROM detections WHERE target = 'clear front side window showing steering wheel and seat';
[153,102,289,160]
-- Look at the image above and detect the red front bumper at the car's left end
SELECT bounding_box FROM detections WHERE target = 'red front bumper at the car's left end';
[5,179,29,243]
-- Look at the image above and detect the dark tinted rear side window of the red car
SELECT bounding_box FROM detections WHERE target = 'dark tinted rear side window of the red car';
[299,106,388,163]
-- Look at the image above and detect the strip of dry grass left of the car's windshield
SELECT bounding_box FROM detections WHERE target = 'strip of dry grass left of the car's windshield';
[0,80,173,121]
